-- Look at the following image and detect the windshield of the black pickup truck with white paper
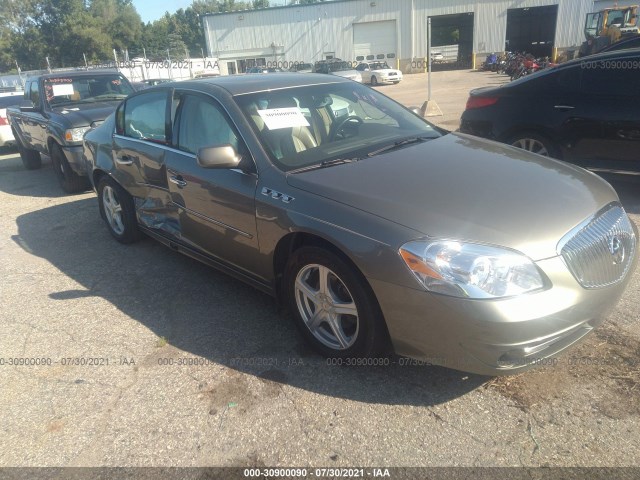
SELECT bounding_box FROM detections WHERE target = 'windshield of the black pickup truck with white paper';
[44,73,133,107]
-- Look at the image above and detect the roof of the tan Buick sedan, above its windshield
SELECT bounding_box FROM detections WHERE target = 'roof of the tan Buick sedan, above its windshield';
[162,72,351,95]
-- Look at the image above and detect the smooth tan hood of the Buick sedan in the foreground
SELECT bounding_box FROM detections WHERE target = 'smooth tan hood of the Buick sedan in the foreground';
[287,133,618,260]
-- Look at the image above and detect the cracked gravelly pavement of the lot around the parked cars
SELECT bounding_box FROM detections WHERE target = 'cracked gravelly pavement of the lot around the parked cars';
[0,72,640,474]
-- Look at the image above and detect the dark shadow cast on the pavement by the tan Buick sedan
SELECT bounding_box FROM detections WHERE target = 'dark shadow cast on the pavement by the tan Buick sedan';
[13,191,487,405]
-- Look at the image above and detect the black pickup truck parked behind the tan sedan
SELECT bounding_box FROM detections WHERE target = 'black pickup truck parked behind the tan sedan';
[7,71,134,193]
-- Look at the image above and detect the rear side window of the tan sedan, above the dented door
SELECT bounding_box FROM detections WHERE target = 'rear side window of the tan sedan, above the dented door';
[122,90,167,143]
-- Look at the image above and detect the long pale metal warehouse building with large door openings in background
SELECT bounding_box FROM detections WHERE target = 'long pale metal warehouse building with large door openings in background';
[202,0,623,73]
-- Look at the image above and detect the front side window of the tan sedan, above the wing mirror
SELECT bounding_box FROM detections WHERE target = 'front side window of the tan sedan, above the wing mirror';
[174,94,239,154]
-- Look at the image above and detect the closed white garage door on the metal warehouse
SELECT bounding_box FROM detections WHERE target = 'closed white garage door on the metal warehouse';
[353,20,398,60]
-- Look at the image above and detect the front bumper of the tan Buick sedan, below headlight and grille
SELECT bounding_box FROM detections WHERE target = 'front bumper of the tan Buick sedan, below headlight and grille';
[369,255,637,375]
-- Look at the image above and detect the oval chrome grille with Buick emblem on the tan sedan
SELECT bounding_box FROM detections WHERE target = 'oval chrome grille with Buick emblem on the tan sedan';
[560,204,636,288]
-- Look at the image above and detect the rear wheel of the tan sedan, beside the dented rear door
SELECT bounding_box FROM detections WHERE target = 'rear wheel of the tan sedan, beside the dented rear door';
[98,177,142,244]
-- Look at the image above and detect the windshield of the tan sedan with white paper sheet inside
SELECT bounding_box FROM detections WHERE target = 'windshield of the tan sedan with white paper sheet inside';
[235,82,441,171]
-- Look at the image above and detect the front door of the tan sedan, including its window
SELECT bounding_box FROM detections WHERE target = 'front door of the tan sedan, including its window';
[165,89,258,273]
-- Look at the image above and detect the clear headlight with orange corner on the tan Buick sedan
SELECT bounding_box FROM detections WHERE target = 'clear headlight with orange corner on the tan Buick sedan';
[400,240,544,299]
